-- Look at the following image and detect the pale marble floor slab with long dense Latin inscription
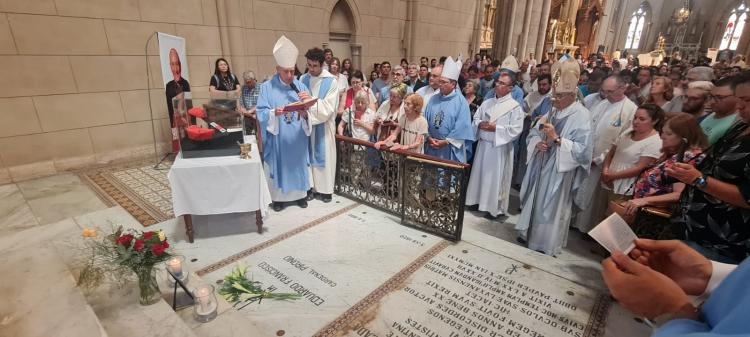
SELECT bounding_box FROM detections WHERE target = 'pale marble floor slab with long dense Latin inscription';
[348,244,608,337]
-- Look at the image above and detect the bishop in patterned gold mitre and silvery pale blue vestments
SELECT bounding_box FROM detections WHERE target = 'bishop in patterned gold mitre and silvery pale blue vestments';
[516,56,591,255]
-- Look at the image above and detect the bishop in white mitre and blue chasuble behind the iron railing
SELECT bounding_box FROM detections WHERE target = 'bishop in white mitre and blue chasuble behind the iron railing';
[425,57,474,163]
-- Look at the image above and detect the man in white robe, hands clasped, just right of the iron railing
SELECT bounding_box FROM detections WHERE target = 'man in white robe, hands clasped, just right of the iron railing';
[466,72,524,219]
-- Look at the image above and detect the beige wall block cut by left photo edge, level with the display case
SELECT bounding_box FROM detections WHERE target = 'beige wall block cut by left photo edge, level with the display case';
[0,97,42,137]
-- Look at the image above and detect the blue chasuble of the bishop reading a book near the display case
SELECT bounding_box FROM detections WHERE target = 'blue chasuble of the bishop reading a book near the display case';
[256,74,310,193]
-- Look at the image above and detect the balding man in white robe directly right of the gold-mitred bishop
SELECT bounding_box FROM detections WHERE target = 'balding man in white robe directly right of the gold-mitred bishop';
[574,75,638,233]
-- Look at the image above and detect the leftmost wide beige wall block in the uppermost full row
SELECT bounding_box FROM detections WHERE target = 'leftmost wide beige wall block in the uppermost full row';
[8,14,109,55]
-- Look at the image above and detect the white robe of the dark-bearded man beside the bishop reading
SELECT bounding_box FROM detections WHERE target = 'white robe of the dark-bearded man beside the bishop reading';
[306,70,339,194]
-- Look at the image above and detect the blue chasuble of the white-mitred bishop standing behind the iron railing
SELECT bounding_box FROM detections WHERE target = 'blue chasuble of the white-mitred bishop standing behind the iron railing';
[424,90,474,163]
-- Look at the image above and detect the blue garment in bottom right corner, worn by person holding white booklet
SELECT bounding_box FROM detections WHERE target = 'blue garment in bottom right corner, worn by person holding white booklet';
[653,259,750,337]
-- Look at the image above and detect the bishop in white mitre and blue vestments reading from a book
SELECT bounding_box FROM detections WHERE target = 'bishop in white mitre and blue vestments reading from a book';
[256,36,312,212]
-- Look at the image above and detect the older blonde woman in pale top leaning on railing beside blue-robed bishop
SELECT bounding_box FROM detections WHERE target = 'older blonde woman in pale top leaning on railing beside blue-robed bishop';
[375,94,427,153]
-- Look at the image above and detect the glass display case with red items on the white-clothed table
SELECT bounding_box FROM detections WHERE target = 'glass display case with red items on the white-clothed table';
[172,91,245,158]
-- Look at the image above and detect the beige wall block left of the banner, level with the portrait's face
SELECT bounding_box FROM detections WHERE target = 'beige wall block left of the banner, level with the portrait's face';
[70,56,148,92]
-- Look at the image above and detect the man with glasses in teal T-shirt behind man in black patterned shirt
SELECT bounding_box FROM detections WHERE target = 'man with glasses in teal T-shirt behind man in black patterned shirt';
[701,77,739,145]
